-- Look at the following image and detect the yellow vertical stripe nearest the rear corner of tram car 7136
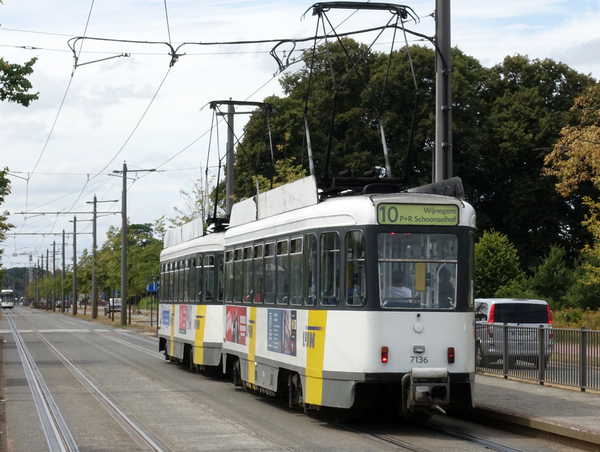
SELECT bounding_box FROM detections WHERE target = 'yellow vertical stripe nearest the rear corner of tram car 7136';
[304,311,327,405]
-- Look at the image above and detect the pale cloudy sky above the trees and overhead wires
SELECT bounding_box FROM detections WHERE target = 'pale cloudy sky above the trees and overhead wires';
[0,0,600,268]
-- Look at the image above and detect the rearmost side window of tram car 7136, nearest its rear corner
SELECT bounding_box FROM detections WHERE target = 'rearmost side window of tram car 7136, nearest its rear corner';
[346,231,367,306]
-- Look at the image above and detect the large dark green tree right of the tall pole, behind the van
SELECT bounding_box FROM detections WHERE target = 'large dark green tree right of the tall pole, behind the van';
[460,55,594,269]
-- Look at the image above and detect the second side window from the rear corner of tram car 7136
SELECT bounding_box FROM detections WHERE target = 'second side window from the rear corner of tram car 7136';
[319,232,340,306]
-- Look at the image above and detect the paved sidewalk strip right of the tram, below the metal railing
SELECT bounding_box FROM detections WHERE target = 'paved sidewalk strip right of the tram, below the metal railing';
[475,374,600,449]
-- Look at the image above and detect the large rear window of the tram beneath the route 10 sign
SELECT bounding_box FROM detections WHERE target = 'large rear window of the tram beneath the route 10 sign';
[377,233,458,309]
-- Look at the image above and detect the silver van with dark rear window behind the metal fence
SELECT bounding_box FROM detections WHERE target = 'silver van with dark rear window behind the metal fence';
[475,298,554,368]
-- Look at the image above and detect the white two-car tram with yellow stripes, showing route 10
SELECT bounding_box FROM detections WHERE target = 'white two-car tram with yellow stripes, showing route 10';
[160,177,475,416]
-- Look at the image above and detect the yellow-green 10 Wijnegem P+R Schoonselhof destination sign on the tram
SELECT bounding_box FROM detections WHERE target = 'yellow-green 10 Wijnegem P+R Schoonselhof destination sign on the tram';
[377,203,458,226]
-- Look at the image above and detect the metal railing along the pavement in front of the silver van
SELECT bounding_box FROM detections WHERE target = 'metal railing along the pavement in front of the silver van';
[475,324,600,391]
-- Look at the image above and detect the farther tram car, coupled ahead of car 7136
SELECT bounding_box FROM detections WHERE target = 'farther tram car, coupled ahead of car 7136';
[158,220,224,368]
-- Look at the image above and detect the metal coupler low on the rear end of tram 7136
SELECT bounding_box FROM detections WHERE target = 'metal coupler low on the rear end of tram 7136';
[402,368,450,414]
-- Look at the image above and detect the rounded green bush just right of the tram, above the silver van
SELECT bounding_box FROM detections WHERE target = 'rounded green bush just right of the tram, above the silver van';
[475,231,524,298]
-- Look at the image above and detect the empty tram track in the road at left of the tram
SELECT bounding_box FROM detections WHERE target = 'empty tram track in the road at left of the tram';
[6,314,171,452]
